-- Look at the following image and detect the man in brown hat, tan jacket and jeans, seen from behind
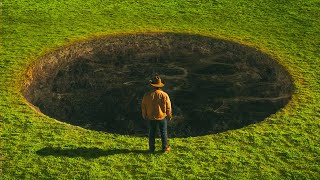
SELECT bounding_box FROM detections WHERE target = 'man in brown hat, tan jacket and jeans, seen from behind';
[141,76,172,152]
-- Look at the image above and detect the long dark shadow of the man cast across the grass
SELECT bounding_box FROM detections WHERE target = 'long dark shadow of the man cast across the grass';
[36,147,156,159]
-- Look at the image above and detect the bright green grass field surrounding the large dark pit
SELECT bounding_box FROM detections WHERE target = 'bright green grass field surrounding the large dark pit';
[0,0,320,179]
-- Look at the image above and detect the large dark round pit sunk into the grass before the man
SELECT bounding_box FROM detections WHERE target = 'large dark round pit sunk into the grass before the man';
[23,33,294,137]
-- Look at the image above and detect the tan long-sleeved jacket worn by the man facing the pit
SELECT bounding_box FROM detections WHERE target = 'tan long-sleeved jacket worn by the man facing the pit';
[141,89,172,120]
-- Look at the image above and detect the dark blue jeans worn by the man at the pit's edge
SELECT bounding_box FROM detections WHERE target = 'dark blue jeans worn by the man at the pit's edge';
[149,117,168,151]
